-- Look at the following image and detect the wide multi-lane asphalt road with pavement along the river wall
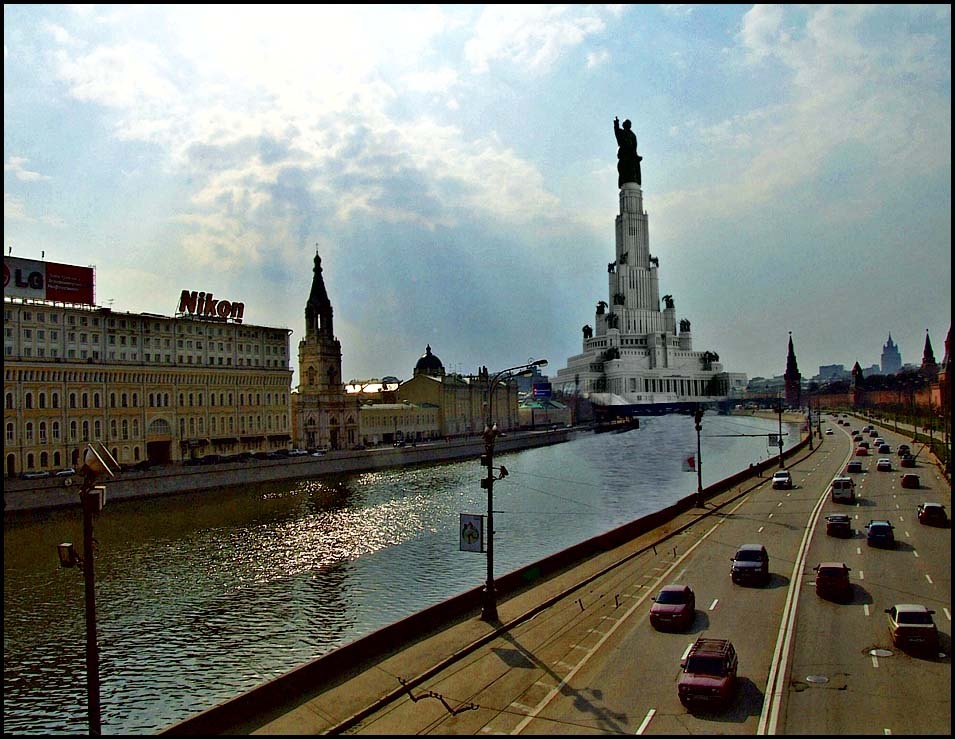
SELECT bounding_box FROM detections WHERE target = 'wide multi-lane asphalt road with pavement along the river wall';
[170,420,951,735]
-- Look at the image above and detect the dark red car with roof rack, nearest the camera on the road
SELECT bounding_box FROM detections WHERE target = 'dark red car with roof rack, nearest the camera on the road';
[677,637,739,710]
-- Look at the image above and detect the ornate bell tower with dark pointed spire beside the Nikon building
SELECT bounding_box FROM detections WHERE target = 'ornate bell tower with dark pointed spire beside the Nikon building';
[294,251,361,449]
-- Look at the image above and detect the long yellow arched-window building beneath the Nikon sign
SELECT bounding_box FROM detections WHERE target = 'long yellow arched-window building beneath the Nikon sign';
[3,291,292,476]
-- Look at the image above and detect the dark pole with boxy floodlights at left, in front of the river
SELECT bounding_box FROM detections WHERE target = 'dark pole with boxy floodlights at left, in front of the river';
[57,444,119,736]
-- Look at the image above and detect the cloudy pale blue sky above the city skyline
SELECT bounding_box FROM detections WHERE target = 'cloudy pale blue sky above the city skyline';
[3,5,951,382]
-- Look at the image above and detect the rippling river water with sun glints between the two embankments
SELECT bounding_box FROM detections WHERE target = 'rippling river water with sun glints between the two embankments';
[3,414,798,734]
